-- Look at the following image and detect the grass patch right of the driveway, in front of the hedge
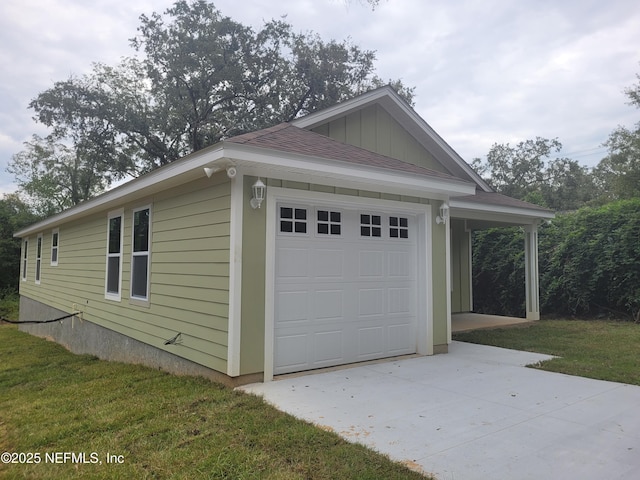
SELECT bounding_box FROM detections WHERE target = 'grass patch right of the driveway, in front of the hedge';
[453,320,640,385]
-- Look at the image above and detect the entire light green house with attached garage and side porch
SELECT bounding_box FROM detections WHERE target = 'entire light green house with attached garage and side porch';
[15,87,553,385]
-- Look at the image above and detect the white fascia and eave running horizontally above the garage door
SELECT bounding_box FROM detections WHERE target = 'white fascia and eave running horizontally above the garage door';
[224,144,475,199]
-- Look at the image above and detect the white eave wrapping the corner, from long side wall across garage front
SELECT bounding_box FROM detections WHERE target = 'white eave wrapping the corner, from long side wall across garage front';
[14,142,475,238]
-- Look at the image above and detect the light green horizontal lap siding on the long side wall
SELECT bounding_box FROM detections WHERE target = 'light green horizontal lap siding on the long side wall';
[20,175,231,373]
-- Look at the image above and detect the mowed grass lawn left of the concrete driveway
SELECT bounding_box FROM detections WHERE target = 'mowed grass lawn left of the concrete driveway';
[0,325,424,480]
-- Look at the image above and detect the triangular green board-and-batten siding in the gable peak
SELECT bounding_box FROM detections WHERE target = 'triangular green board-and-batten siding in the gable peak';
[312,105,450,173]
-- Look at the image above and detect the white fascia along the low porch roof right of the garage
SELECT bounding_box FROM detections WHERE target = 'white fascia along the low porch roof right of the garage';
[449,199,555,223]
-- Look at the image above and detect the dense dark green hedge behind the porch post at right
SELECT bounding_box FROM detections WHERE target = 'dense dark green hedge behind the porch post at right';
[473,198,640,321]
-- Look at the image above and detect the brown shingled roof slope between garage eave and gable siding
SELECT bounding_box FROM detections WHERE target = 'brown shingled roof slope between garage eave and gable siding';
[225,123,468,183]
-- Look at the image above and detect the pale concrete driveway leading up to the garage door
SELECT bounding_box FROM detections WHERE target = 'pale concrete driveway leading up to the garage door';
[241,342,640,480]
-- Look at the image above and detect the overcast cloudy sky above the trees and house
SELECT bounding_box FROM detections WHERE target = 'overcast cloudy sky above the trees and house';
[0,0,640,193]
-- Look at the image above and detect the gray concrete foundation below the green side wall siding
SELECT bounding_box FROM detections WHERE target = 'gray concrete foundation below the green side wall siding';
[20,296,263,387]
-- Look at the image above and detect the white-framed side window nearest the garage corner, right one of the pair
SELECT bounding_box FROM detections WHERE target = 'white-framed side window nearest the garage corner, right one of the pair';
[131,207,151,300]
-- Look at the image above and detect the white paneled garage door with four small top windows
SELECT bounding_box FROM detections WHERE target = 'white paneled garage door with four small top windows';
[274,203,417,374]
